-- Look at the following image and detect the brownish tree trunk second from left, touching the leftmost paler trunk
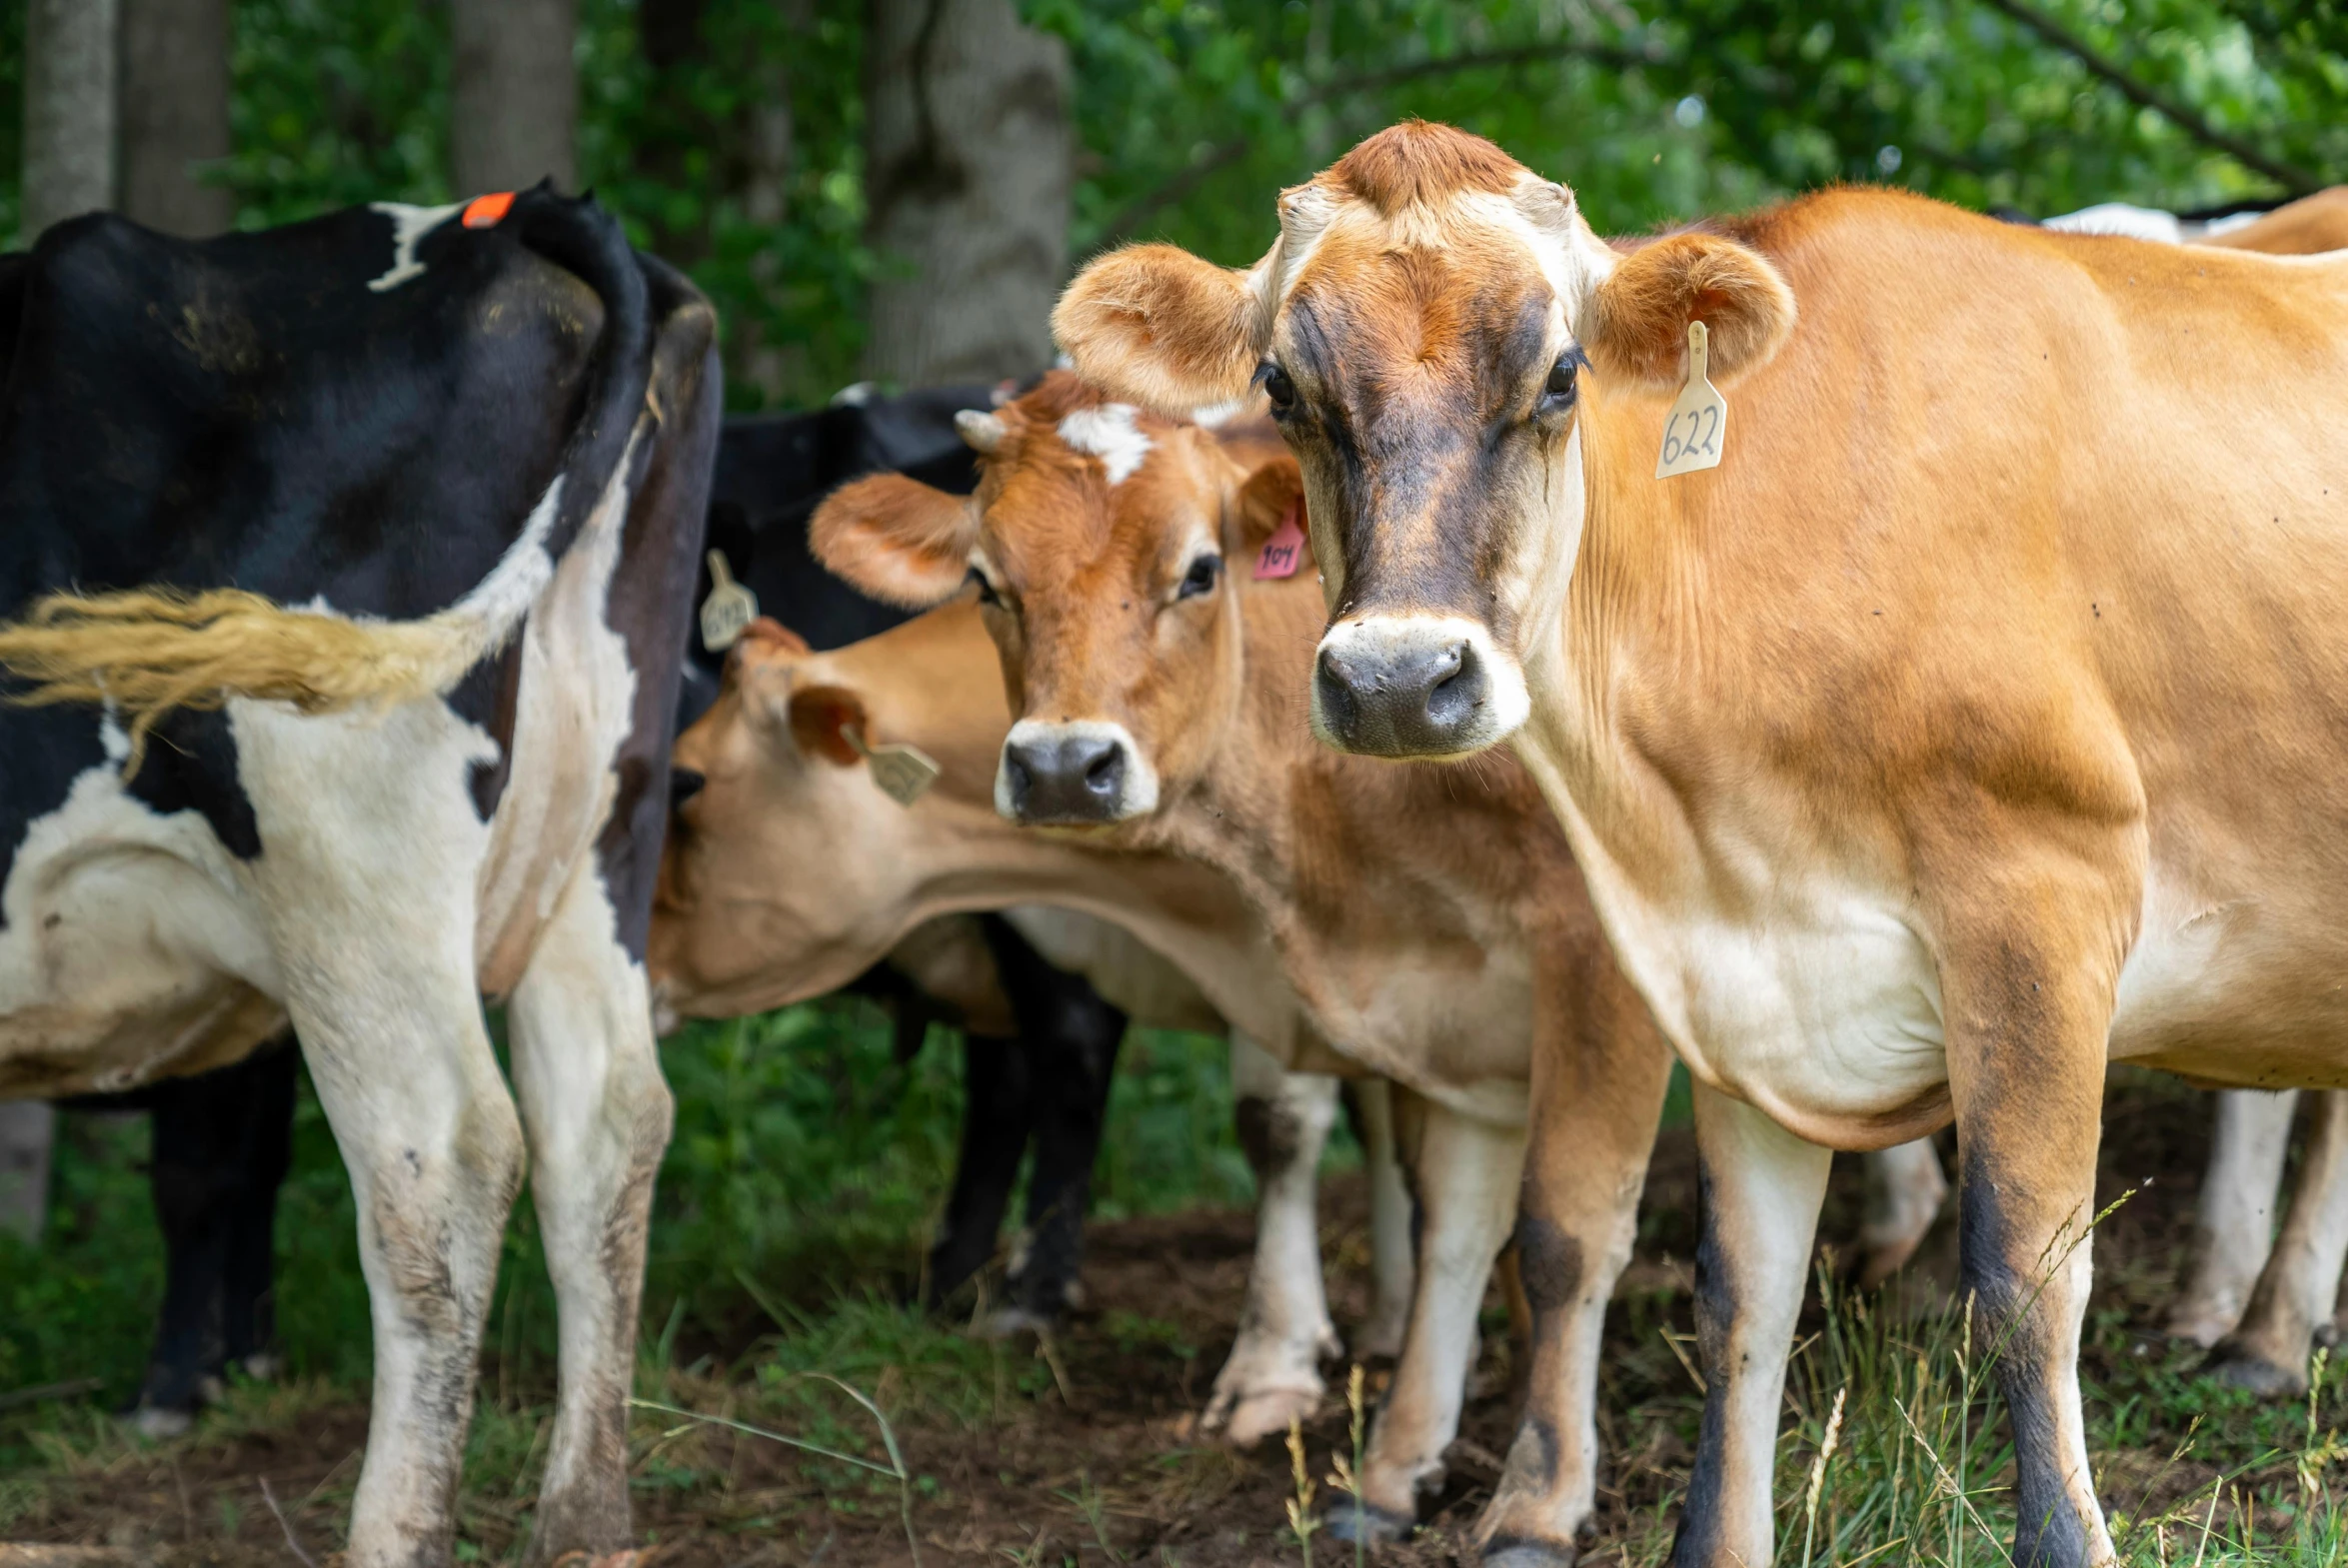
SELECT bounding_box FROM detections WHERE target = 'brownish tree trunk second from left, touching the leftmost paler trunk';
[120,0,237,237]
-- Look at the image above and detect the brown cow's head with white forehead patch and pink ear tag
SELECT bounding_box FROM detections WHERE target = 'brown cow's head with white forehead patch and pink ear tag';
[810,371,1298,826]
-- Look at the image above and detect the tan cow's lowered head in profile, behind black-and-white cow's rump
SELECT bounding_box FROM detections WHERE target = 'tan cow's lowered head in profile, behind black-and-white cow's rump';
[648,618,1005,1016]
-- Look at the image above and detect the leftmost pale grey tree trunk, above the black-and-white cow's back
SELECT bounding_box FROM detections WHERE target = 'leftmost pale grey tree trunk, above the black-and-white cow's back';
[23,0,115,244]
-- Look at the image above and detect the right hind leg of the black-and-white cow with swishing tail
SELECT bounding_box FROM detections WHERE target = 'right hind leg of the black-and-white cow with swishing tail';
[507,866,672,1563]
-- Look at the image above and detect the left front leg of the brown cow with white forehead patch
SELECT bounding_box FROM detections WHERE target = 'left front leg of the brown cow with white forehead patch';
[1329,1084,1524,1540]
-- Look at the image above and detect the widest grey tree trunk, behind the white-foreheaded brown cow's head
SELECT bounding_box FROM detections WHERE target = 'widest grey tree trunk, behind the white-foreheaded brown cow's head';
[864,0,1073,385]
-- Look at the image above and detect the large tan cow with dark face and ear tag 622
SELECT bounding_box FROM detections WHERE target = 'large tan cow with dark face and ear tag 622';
[1057,122,2348,1563]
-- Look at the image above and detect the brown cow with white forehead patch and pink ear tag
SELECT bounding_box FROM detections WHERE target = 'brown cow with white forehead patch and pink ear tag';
[813,371,1669,1552]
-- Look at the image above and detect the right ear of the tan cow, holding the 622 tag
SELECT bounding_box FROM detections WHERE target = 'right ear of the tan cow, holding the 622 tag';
[1580,235,1794,392]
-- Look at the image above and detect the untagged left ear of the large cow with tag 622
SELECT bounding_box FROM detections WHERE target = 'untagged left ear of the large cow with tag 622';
[1052,244,1263,416]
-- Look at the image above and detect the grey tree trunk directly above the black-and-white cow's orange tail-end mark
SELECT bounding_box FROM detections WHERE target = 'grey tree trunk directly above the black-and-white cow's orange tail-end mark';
[449,0,580,197]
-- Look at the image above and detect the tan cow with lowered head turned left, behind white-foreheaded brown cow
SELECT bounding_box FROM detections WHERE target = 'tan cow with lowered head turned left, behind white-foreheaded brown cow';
[651,606,1411,1441]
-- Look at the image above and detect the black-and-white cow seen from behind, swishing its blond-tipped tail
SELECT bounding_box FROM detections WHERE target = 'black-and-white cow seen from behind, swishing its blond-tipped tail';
[0,188,721,1566]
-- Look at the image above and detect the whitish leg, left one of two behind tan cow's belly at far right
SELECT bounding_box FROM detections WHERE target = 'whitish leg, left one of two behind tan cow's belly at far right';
[2165,1089,2299,1350]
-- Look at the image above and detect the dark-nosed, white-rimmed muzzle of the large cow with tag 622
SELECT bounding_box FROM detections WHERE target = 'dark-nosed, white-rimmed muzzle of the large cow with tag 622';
[1312,615,1531,759]
